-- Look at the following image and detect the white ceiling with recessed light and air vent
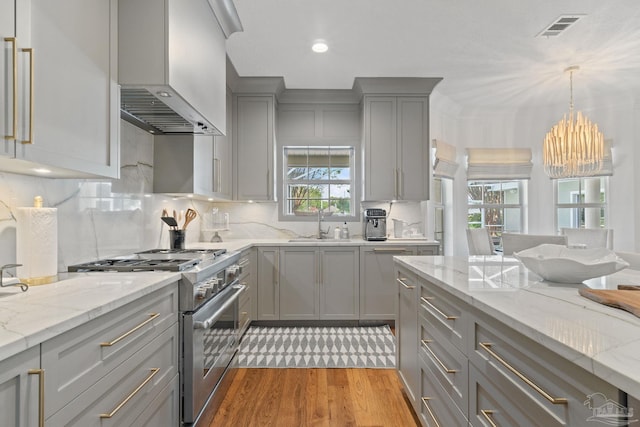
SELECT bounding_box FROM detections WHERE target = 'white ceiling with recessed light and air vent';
[227,0,640,108]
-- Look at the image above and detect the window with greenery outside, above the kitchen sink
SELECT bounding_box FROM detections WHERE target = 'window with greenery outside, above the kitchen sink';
[283,146,355,220]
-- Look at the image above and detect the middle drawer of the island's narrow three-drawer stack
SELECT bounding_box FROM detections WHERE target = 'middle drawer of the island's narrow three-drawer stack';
[419,316,469,414]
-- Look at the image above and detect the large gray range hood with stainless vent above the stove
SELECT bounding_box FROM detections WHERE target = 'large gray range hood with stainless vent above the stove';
[118,0,242,135]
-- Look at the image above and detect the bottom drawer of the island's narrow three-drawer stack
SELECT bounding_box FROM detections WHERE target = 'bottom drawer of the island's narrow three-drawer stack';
[419,360,468,427]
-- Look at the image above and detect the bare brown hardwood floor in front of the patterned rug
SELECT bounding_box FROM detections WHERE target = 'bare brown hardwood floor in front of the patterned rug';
[204,368,420,427]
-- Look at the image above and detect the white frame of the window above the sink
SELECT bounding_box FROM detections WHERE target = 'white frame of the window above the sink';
[279,145,359,222]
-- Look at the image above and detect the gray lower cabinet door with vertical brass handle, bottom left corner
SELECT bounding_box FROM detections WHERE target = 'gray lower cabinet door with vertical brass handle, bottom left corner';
[0,346,43,427]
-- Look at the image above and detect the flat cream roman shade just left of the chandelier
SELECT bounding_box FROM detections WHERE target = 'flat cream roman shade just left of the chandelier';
[467,148,533,180]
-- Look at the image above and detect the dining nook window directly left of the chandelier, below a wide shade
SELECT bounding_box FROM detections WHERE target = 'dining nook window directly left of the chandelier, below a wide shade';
[467,180,526,246]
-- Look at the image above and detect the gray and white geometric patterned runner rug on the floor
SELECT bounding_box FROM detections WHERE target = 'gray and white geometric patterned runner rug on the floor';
[238,326,396,368]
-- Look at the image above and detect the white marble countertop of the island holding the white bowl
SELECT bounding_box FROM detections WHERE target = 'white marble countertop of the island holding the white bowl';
[395,256,640,398]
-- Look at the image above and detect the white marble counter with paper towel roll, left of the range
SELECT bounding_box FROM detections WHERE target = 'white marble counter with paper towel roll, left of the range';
[0,272,180,360]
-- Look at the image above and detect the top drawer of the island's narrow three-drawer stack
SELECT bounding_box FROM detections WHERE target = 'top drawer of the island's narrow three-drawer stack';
[418,280,469,353]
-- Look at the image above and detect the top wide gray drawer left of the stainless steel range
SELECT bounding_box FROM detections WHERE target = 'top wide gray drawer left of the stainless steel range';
[42,285,178,415]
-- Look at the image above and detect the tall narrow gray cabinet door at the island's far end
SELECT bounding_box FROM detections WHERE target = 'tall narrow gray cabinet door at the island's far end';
[395,267,419,413]
